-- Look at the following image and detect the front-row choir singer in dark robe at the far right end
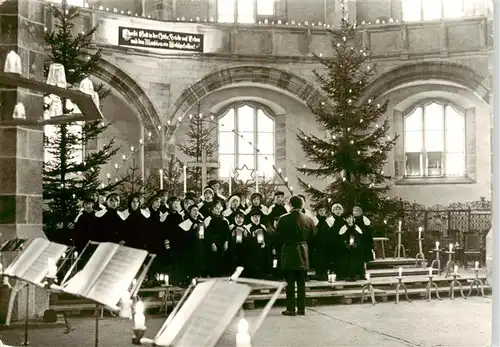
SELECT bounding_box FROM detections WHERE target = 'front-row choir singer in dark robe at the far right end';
[337,214,365,281]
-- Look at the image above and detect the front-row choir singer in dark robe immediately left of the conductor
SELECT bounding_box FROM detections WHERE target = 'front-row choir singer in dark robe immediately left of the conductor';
[244,208,272,279]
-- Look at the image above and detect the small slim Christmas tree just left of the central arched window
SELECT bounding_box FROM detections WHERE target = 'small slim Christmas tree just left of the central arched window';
[177,106,217,195]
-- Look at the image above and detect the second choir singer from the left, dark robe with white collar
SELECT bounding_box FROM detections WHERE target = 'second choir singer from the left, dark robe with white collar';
[92,193,125,243]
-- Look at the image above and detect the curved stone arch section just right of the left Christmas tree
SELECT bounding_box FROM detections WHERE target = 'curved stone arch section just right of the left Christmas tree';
[93,59,161,132]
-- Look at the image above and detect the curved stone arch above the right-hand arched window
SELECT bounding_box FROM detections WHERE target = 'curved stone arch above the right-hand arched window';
[365,61,490,104]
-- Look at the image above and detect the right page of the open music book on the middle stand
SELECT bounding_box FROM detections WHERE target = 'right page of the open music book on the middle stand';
[87,246,148,308]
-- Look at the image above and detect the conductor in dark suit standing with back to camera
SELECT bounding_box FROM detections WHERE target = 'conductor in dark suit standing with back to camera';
[276,196,315,316]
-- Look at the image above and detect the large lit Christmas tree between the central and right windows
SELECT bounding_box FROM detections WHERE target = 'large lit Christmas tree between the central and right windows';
[298,8,397,218]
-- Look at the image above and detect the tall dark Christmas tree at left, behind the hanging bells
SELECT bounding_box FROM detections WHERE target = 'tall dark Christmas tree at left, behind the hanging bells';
[43,0,121,242]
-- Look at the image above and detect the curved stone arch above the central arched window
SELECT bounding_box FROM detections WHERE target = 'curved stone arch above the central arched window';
[170,65,322,123]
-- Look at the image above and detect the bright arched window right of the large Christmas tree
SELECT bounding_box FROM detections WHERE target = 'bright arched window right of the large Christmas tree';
[404,101,466,177]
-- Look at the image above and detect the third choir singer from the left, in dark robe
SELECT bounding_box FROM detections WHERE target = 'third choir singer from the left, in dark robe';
[122,194,149,249]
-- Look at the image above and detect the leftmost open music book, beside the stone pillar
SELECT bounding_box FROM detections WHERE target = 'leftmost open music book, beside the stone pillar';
[4,238,68,287]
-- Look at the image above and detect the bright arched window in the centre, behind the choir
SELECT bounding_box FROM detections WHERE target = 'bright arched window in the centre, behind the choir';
[218,103,275,179]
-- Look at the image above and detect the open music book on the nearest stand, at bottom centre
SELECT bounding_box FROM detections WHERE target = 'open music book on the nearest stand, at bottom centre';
[154,280,251,347]
